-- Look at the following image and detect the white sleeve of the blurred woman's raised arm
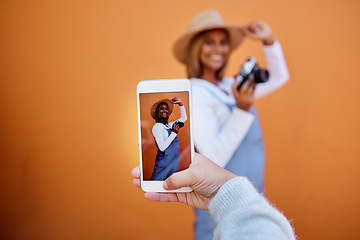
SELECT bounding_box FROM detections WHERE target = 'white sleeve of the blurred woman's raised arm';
[254,40,289,98]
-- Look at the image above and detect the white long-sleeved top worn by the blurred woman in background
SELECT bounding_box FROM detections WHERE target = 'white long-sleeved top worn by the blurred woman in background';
[191,41,289,167]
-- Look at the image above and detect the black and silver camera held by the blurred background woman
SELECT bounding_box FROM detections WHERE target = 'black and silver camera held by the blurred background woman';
[235,57,269,90]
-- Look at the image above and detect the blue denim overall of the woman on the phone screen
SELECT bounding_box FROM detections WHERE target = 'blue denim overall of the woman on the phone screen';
[150,129,179,181]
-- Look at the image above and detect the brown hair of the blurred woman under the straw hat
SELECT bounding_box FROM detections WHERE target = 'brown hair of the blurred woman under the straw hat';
[185,29,231,80]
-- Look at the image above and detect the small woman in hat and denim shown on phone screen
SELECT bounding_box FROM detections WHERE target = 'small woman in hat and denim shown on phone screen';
[150,97,187,181]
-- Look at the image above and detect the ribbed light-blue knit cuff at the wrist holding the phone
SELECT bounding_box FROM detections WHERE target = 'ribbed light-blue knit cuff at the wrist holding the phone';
[208,177,266,224]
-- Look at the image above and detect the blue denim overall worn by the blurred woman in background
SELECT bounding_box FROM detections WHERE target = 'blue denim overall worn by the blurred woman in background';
[194,106,265,240]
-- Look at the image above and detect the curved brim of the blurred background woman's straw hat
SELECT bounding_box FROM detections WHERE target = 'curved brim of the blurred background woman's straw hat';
[173,25,244,63]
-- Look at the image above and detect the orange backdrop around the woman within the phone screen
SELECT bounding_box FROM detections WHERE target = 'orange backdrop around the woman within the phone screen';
[140,92,191,180]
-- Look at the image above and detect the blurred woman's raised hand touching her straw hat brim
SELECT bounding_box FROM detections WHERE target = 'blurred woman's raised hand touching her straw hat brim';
[242,20,275,45]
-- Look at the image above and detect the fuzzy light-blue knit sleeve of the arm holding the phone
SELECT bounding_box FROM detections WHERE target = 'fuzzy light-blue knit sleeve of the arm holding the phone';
[208,177,295,240]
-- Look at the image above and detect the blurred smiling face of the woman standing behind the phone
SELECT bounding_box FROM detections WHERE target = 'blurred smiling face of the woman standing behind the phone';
[200,29,230,73]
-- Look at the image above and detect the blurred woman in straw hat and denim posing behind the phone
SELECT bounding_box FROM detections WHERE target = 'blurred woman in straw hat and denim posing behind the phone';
[173,10,289,239]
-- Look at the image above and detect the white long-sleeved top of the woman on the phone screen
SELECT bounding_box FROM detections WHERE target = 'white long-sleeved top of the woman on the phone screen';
[152,106,187,152]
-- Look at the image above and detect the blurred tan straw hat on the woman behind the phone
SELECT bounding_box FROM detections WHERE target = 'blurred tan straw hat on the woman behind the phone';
[173,9,244,63]
